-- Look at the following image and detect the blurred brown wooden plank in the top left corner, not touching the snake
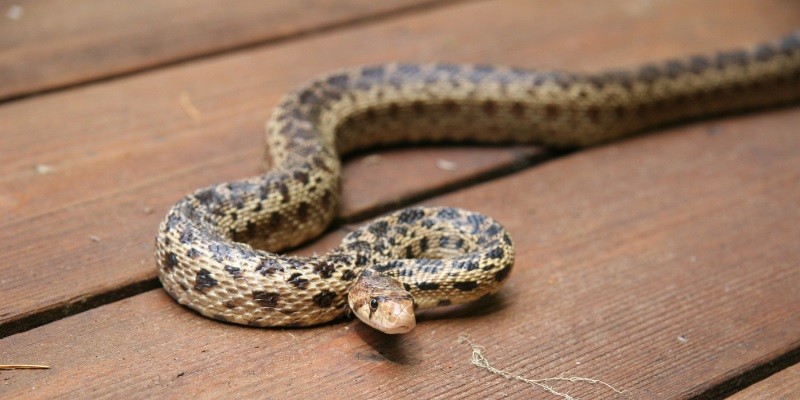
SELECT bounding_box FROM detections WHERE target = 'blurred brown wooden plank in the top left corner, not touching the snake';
[0,0,450,100]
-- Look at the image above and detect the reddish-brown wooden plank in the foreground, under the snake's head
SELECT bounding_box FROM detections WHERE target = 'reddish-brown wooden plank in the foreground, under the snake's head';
[0,99,800,399]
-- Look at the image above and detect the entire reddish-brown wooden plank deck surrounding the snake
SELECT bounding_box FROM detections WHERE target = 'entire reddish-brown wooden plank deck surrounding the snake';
[0,0,800,399]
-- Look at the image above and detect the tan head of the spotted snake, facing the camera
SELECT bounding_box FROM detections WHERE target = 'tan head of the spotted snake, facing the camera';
[347,270,417,334]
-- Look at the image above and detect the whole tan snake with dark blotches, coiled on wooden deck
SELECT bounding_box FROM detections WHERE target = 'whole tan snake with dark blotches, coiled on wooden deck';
[155,30,800,334]
